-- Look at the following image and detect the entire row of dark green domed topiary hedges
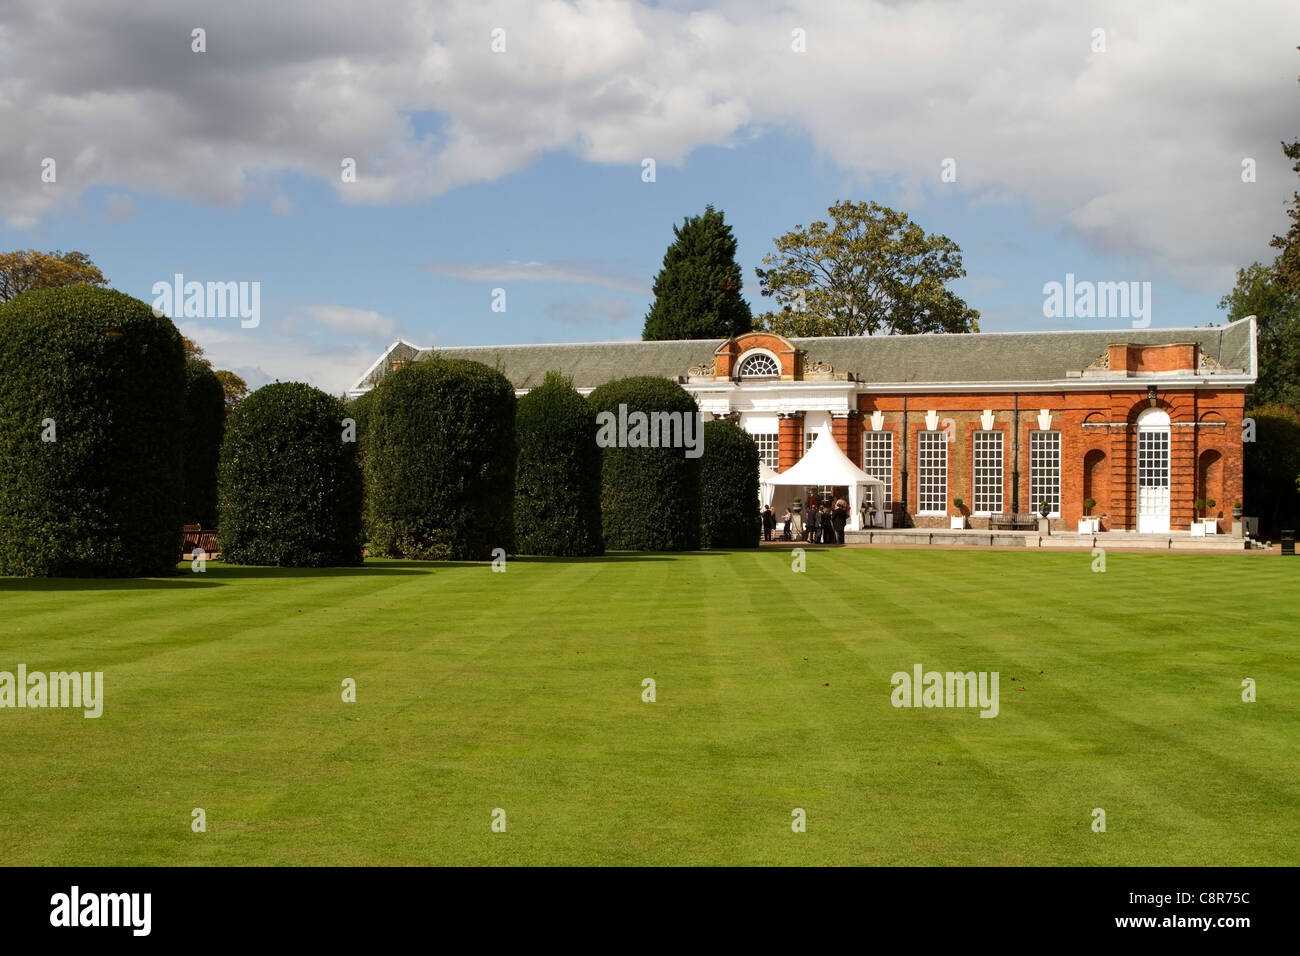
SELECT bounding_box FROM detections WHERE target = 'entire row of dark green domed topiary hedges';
[0,286,758,576]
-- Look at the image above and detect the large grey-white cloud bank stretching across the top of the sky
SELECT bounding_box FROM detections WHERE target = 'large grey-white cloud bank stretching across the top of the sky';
[0,0,1300,287]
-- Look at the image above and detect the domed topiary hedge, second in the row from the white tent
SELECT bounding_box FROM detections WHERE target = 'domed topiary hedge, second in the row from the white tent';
[588,376,702,551]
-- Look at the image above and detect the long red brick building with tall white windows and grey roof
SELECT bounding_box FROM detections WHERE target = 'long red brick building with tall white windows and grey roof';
[350,319,1256,533]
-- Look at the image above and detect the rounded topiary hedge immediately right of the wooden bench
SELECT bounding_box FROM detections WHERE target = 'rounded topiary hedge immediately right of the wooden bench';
[217,382,361,567]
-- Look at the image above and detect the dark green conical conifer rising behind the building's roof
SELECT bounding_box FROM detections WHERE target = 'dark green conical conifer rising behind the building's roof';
[641,206,754,342]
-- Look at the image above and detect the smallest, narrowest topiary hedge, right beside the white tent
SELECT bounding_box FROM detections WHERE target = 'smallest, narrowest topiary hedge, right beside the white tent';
[699,420,759,548]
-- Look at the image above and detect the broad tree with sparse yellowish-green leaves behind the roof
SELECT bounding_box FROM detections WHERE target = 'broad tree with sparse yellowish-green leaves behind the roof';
[755,200,979,336]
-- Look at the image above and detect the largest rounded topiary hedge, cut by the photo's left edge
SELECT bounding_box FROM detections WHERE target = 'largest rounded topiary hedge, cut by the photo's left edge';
[0,285,185,576]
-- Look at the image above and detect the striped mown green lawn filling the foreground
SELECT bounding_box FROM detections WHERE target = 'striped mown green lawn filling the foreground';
[0,549,1300,865]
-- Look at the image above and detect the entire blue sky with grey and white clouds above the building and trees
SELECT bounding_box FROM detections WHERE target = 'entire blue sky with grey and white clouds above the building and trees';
[0,0,1300,392]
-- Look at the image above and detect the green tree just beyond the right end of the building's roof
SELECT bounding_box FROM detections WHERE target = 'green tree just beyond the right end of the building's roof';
[1219,264,1300,408]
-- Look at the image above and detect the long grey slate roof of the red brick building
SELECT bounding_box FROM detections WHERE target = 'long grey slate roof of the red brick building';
[354,319,1256,390]
